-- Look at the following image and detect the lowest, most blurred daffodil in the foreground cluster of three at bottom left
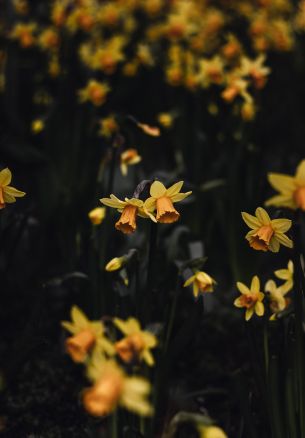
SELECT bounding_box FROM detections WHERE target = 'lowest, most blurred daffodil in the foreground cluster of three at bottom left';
[82,356,152,416]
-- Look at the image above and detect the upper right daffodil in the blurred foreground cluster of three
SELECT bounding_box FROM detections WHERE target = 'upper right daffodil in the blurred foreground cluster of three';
[113,318,157,366]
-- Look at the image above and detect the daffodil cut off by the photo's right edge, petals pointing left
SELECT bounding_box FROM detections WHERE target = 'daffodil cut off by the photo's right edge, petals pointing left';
[265,160,305,211]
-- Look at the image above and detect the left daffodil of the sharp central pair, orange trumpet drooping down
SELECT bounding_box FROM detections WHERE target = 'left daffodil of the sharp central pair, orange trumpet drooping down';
[100,195,156,234]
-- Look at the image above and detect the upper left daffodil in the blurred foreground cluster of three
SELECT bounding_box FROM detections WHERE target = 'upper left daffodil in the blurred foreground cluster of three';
[61,306,114,362]
